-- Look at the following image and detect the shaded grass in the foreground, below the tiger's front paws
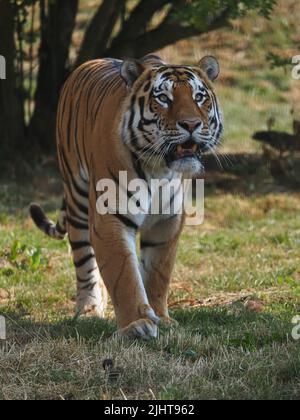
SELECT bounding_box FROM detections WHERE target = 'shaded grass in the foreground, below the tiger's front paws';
[0,308,300,399]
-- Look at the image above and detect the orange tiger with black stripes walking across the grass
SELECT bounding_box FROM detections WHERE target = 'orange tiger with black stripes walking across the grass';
[30,55,223,340]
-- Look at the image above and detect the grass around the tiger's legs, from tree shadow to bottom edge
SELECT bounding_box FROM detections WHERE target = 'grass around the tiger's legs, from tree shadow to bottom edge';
[0,176,300,399]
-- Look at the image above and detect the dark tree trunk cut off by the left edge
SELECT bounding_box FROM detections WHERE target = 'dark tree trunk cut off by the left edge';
[0,0,24,156]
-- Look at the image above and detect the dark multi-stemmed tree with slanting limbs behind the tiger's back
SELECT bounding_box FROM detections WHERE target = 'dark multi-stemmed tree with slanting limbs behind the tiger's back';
[29,0,228,151]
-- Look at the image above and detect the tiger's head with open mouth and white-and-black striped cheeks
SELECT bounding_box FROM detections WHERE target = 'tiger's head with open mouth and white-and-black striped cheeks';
[121,56,223,176]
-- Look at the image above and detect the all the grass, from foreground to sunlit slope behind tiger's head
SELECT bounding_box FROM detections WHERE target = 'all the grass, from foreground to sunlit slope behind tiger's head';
[0,0,300,400]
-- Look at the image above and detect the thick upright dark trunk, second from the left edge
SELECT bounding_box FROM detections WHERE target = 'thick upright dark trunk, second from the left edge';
[29,0,78,151]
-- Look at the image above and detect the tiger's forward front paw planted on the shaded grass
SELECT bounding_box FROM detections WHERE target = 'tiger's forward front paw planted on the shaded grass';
[118,318,158,341]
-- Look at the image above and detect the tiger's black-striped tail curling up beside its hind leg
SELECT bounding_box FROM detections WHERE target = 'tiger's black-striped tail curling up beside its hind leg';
[30,200,67,241]
